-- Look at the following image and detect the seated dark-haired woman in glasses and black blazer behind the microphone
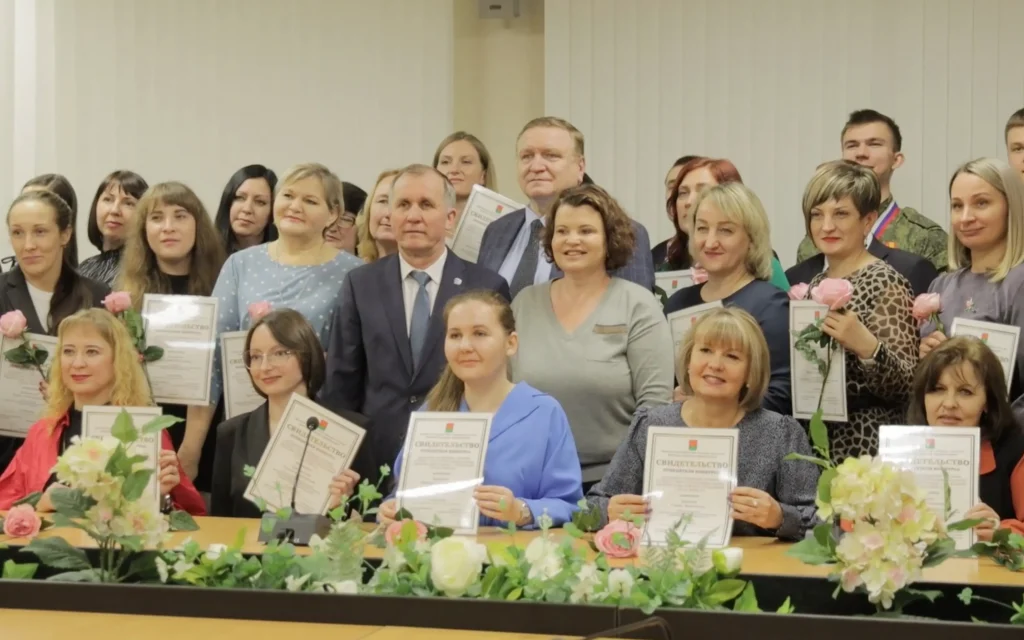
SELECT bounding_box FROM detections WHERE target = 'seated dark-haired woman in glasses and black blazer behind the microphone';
[210,309,366,518]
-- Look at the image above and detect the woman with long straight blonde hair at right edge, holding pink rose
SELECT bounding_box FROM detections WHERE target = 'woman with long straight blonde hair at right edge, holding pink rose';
[921,158,1024,408]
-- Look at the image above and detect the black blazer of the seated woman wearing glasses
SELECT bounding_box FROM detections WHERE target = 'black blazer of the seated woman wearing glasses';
[210,402,373,518]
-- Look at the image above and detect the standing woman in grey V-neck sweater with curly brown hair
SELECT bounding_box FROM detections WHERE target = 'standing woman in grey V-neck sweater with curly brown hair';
[512,184,673,490]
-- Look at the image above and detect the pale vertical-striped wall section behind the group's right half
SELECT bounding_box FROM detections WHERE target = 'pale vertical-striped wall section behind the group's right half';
[545,0,1024,265]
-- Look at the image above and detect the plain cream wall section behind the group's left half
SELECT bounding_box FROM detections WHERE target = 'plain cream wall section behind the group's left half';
[0,0,455,258]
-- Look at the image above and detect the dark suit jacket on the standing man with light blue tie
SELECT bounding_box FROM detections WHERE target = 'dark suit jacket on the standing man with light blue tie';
[319,251,510,481]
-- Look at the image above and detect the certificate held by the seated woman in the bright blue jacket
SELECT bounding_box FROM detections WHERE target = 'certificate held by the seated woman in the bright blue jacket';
[397,412,491,536]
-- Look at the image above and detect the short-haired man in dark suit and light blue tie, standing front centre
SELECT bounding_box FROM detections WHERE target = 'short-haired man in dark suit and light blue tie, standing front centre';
[321,165,510,481]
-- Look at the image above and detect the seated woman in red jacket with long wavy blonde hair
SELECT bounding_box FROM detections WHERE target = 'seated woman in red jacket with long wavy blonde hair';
[0,309,206,515]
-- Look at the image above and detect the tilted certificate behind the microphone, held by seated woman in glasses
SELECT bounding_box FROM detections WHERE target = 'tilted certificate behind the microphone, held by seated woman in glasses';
[244,393,367,515]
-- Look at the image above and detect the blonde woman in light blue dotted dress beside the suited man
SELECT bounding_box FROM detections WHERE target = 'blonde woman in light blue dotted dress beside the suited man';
[184,163,362,481]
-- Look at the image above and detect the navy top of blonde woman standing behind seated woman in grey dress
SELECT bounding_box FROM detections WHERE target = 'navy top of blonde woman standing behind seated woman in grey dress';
[665,280,793,416]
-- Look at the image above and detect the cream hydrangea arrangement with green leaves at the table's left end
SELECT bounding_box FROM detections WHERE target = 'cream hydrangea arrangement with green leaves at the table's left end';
[3,411,199,583]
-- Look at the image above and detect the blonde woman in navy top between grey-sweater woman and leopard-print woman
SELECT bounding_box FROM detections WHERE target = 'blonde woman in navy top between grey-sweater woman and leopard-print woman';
[665,182,793,415]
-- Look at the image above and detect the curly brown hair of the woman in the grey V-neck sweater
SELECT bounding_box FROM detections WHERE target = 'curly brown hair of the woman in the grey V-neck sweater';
[541,183,636,272]
